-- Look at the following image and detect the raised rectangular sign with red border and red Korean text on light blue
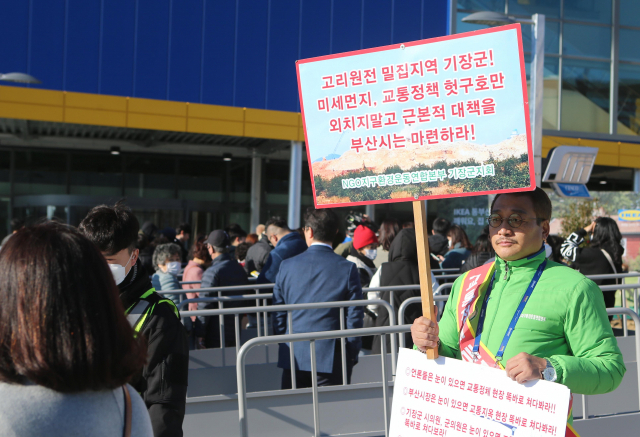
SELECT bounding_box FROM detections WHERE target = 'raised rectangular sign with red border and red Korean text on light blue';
[297,24,535,208]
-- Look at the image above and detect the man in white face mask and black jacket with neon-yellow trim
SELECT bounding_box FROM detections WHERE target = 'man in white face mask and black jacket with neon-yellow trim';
[79,202,189,437]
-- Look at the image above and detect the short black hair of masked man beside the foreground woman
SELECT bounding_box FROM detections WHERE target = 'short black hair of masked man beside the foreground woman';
[78,202,140,255]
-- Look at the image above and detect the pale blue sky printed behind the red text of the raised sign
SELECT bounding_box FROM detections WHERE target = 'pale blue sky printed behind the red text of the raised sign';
[299,29,526,164]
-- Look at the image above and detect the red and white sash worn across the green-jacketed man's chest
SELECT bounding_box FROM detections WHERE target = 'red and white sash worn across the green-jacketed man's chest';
[456,263,580,437]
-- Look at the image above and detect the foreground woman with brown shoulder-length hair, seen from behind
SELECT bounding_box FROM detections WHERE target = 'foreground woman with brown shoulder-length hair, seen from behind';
[0,223,153,437]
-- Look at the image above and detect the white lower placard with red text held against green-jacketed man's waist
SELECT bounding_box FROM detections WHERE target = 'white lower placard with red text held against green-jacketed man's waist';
[389,349,571,437]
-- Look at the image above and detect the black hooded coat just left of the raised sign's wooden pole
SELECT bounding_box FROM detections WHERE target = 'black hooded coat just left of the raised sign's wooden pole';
[372,228,422,353]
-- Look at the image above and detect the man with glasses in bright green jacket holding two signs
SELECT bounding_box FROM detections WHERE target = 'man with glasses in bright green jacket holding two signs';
[411,188,626,421]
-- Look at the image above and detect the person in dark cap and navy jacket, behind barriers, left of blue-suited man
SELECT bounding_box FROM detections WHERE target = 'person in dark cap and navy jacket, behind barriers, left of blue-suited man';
[198,229,249,348]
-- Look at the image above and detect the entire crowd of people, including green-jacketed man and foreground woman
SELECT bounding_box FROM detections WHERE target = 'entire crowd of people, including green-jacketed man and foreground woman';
[0,189,624,437]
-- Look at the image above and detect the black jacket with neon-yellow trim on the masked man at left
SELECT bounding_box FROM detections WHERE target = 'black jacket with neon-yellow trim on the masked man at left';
[118,260,189,437]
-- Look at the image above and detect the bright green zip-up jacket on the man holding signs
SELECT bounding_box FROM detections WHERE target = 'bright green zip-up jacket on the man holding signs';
[439,250,627,395]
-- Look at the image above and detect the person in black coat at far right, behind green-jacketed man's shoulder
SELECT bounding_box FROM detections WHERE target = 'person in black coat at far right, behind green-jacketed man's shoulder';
[560,217,624,308]
